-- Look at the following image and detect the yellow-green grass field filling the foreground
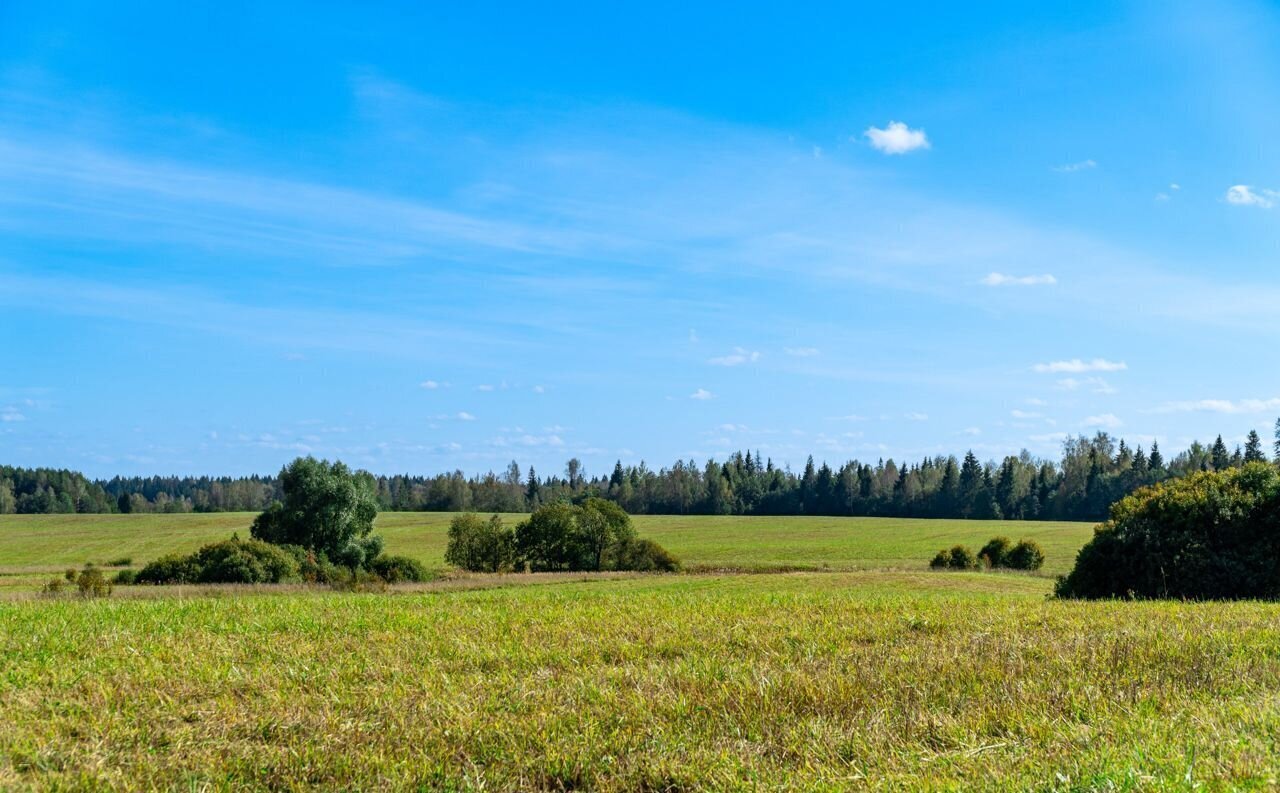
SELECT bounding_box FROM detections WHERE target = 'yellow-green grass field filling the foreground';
[0,572,1280,790]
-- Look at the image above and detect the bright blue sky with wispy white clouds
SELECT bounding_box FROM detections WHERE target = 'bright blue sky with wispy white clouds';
[0,0,1280,477]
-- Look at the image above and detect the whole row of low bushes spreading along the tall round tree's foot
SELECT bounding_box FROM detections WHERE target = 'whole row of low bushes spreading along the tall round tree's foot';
[133,536,430,585]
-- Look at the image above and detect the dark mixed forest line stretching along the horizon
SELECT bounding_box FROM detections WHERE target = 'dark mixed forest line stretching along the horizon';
[0,421,1280,521]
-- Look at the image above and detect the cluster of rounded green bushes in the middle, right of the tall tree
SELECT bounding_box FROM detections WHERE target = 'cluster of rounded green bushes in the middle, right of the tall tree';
[444,499,680,573]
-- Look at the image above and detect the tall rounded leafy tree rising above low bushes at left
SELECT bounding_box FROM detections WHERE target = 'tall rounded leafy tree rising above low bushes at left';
[250,457,381,567]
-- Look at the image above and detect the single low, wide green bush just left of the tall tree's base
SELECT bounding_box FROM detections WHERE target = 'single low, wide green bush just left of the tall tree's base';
[134,537,300,583]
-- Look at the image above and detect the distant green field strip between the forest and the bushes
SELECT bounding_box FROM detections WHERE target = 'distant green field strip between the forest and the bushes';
[0,513,1092,573]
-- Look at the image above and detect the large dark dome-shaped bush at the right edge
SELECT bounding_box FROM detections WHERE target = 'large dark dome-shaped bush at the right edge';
[1057,463,1280,600]
